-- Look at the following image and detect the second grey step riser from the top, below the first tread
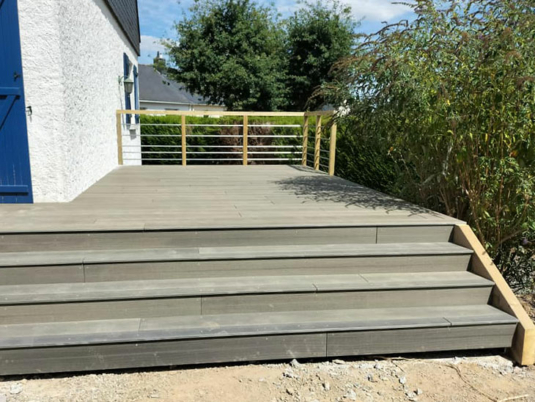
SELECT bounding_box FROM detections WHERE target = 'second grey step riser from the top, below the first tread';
[0,255,470,285]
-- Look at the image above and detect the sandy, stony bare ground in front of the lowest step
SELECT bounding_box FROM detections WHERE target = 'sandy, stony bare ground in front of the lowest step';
[0,355,535,402]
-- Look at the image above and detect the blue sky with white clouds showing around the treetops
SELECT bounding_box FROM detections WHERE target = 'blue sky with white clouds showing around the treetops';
[138,0,412,64]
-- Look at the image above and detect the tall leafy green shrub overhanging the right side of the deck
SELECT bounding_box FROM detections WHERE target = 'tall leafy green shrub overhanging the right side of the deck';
[324,0,535,256]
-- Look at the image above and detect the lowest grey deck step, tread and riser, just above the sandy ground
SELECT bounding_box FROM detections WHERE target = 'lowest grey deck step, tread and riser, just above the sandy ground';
[0,305,517,375]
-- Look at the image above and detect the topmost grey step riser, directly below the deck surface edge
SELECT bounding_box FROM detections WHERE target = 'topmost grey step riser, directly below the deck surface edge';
[0,226,453,252]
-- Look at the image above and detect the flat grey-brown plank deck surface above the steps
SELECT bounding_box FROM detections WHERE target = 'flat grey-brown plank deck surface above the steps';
[0,166,460,233]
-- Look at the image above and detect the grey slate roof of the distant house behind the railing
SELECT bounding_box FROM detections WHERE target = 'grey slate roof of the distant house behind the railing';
[139,64,208,105]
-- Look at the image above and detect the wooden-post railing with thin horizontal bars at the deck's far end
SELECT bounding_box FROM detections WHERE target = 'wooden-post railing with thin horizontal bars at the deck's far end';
[116,110,337,176]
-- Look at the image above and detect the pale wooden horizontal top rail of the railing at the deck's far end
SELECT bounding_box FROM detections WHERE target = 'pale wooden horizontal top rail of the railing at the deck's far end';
[117,109,335,117]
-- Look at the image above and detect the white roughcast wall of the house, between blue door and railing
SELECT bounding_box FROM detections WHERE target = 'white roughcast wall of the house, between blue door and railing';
[19,0,139,202]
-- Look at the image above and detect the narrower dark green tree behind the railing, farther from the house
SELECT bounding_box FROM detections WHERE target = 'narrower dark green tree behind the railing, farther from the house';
[286,0,357,110]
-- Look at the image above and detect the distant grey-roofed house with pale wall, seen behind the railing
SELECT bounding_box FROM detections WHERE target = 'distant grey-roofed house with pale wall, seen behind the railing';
[139,64,225,111]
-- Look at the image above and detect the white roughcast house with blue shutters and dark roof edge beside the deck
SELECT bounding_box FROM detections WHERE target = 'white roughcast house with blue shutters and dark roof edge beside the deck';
[0,0,140,203]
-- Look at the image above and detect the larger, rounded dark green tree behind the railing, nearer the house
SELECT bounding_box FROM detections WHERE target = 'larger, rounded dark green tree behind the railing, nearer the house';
[166,0,286,110]
